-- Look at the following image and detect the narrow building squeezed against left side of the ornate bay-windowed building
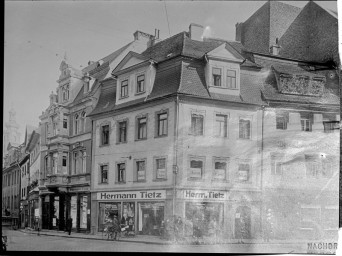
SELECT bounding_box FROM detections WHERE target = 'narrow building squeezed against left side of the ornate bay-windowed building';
[26,128,41,228]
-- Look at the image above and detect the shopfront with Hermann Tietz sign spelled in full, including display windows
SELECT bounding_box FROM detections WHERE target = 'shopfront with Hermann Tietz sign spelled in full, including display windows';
[92,190,172,235]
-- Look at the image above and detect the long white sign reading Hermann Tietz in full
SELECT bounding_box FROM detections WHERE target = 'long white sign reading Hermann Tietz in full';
[97,190,166,200]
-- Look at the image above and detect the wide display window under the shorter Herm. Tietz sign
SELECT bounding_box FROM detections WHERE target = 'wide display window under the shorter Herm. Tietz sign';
[184,202,223,237]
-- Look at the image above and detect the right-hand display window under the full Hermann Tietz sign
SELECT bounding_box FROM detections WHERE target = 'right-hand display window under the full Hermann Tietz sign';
[138,202,165,235]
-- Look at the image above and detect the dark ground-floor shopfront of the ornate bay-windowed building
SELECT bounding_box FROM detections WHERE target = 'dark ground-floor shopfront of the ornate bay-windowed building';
[40,187,91,232]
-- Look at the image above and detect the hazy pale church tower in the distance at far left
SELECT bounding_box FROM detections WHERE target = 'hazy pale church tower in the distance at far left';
[2,108,20,161]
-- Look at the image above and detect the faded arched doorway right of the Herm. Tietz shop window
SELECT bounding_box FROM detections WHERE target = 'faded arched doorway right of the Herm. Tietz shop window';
[235,206,251,239]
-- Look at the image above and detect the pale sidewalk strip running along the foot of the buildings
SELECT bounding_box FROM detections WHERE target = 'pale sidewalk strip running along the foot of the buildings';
[18,228,307,245]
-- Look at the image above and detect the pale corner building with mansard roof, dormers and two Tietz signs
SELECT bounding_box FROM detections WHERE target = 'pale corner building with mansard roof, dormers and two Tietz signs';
[91,24,263,238]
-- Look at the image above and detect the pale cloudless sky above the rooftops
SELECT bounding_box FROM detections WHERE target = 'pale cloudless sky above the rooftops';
[3,0,342,142]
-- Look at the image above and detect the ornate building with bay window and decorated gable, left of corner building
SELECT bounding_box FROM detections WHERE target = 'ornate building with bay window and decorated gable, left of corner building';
[39,31,155,231]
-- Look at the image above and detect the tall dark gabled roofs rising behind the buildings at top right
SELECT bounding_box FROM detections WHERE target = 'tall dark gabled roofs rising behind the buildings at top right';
[236,1,340,66]
